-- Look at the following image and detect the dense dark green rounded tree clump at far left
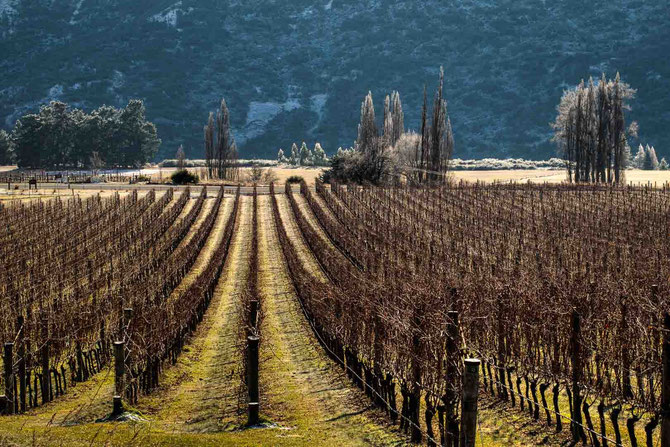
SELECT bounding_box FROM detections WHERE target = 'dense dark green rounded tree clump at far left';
[0,99,161,169]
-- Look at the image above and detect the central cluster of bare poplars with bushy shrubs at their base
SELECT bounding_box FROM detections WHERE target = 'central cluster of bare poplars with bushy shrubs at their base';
[324,67,454,184]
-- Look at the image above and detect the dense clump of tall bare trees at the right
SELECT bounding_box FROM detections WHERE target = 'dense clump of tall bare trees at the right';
[553,73,637,183]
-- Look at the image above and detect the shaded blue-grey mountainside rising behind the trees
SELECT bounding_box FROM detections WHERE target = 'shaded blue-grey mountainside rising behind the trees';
[0,0,670,158]
